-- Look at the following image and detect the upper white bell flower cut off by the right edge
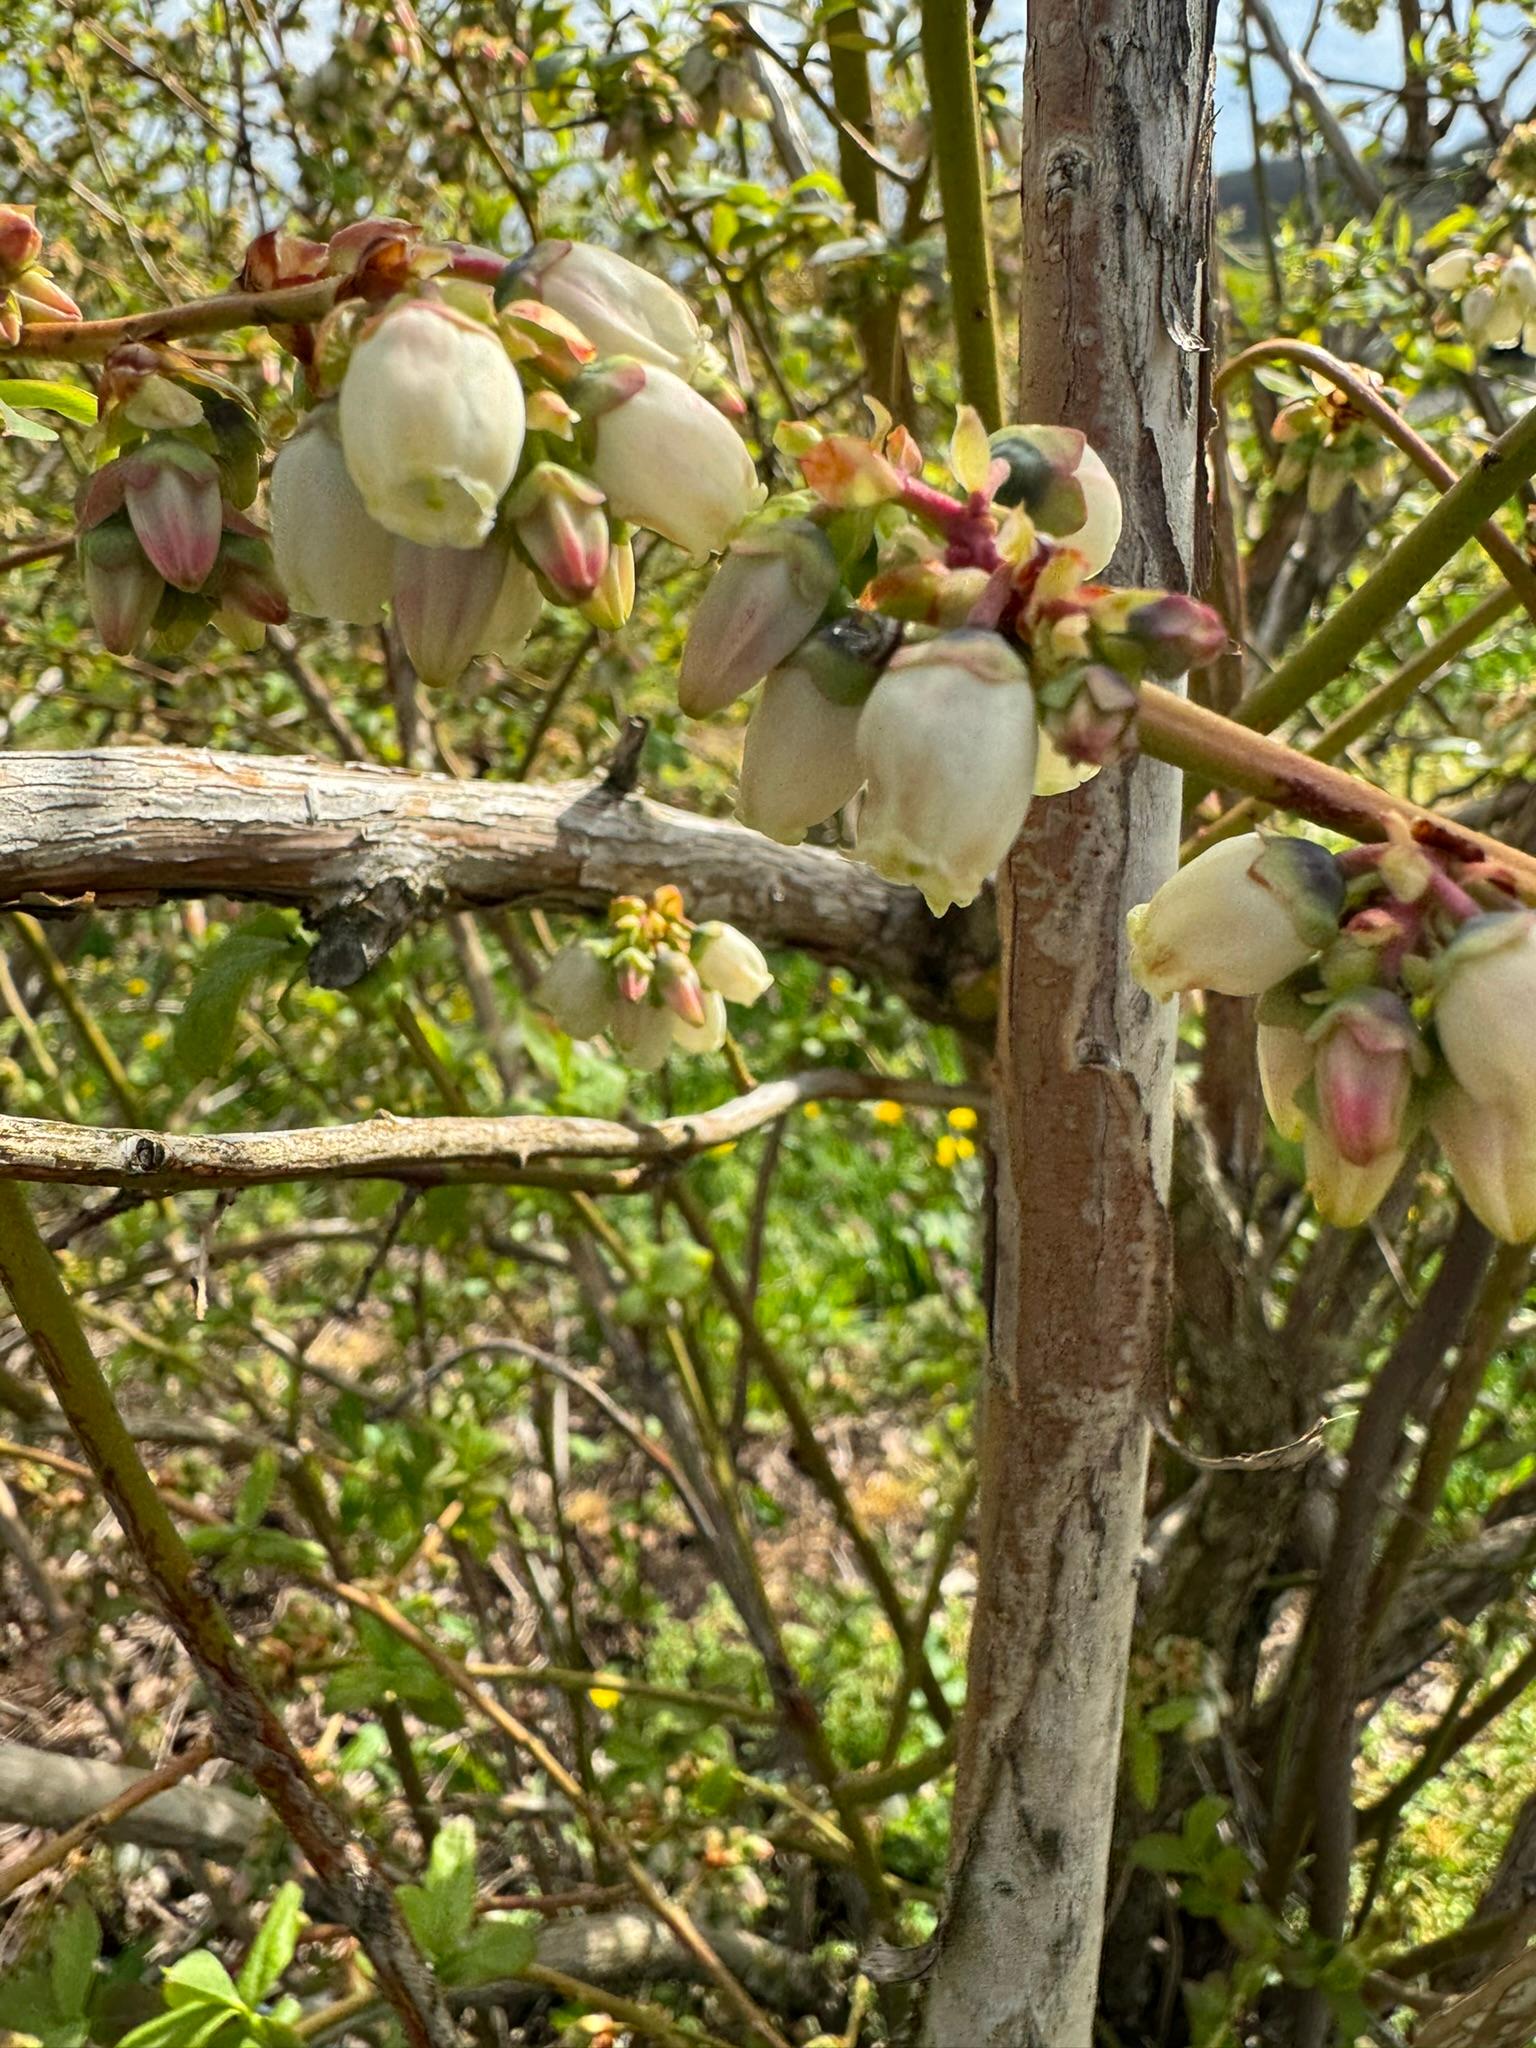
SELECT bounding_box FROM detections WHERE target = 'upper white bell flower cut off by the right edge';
[1434,909,1536,1114]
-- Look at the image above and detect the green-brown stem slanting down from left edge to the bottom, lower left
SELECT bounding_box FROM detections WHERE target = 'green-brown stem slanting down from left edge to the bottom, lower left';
[0,1180,457,2048]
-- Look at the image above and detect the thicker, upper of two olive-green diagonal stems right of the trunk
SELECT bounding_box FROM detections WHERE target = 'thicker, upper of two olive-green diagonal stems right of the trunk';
[1236,406,1536,737]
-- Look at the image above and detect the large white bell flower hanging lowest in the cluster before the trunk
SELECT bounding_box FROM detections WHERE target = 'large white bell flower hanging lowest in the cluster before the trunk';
[854,633,1036,918]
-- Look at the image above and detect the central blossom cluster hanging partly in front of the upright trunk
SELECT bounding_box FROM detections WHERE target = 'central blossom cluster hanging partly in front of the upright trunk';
[680,408,1227,913]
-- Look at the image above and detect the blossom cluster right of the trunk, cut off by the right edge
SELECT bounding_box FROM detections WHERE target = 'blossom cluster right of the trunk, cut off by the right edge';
[1130,834,1536,1243]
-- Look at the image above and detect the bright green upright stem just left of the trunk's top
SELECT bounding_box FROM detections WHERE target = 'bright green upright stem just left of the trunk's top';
[922,0,1003,432]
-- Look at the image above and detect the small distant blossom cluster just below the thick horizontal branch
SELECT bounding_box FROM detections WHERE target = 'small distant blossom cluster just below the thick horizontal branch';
[535,883,774,1071]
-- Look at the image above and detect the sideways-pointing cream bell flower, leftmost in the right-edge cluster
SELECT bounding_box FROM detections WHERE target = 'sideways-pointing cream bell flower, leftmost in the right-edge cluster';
[1126,831,1343,999]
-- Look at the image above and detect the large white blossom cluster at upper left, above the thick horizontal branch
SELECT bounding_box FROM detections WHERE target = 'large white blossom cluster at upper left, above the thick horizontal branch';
[259,221,764,684]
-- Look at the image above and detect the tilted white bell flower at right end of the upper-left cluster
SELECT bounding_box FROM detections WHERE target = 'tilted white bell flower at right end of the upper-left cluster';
[578,365,766,555]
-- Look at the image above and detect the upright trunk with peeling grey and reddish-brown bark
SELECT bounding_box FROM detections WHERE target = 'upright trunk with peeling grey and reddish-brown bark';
[924,0,1217,2048]
